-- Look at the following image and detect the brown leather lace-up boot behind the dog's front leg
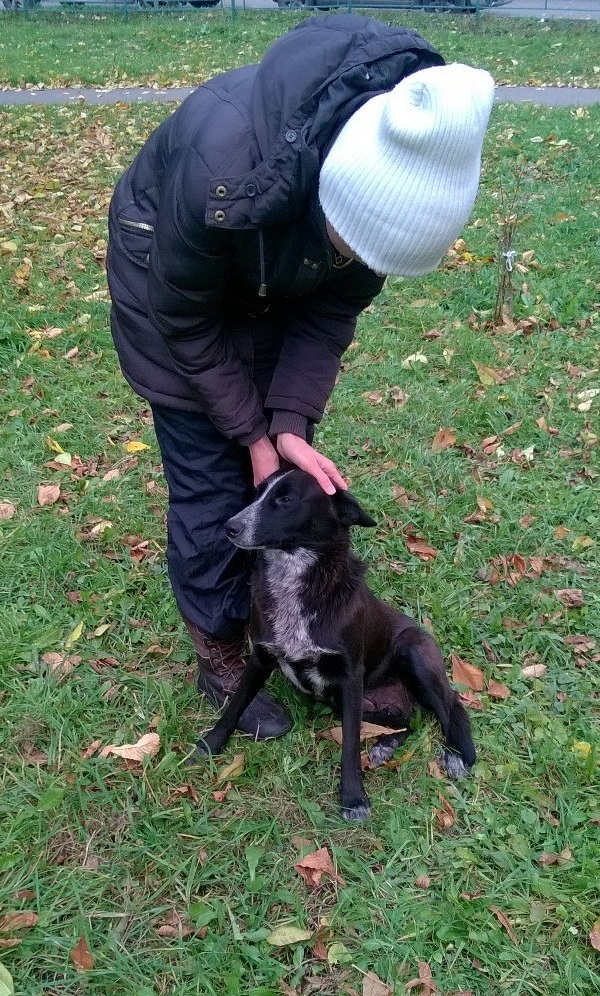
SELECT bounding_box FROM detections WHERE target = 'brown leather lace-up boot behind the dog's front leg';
[183,618,292,740]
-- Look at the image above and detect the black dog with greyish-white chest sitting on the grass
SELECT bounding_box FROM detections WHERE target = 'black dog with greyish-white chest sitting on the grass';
[198,469,475,820]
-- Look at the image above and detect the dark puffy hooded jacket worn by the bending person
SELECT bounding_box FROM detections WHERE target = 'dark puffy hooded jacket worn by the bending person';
[107,14,443,444]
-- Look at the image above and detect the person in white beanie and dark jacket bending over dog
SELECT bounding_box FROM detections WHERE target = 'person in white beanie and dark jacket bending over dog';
[107,7,494,738]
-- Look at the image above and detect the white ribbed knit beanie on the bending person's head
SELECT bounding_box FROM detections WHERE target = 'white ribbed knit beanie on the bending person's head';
[319,63,494,276]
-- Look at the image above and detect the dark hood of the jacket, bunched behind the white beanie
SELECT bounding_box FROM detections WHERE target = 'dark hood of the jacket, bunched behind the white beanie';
[206,14,444,228]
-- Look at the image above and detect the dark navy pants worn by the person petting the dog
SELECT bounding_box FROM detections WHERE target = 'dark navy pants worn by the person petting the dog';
[151,319,300,640]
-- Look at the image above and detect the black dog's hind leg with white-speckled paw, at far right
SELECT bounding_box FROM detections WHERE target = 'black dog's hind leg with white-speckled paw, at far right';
[396,626,476,778]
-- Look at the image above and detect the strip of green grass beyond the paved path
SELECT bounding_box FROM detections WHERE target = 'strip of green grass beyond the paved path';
[0,9,600,87]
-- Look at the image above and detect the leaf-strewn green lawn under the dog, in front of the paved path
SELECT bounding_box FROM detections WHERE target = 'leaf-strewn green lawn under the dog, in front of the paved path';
[0,18,600,996]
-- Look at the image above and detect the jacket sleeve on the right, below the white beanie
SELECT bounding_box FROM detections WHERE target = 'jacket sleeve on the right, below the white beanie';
[265,264,385,436]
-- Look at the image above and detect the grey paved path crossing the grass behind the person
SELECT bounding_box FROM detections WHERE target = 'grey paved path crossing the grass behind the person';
[0,86,600,107]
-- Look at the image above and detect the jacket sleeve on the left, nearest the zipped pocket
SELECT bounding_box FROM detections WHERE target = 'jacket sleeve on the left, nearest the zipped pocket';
[148,147,267,445]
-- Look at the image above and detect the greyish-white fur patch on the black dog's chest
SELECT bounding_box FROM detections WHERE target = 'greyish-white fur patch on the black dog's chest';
[263,549,332,680]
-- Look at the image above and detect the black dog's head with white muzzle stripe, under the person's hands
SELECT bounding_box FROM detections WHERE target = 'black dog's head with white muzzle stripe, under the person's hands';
[225,468,376,550]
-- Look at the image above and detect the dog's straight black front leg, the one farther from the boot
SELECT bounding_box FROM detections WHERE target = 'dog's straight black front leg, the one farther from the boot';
[340,666,371,821]
